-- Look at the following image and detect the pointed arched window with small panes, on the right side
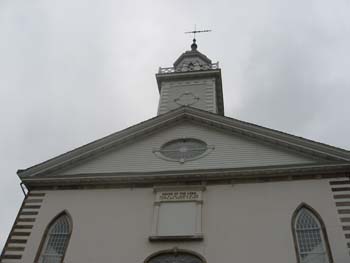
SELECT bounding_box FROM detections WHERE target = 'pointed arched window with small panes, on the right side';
[292,204,332,263]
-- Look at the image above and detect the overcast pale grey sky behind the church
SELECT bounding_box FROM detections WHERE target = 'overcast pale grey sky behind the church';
[0,0,350,250]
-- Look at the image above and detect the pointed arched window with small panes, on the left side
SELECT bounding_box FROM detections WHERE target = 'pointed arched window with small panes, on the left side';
[36,212,72,263]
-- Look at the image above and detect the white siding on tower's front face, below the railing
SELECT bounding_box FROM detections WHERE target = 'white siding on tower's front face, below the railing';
[158,78,217,115]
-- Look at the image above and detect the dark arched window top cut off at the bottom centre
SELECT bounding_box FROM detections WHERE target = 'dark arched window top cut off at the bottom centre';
[145,248,206,263]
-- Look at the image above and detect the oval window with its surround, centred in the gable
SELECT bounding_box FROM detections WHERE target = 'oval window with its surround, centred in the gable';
[153,138,214,163]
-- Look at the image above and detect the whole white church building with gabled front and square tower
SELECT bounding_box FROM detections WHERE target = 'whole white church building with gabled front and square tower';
[0,40,350,263]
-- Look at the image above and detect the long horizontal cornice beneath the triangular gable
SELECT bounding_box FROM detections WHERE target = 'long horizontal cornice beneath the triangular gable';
[22,163,350,189]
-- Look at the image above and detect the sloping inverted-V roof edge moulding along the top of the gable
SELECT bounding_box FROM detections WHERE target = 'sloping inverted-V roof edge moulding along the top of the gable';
[17,106,350,178]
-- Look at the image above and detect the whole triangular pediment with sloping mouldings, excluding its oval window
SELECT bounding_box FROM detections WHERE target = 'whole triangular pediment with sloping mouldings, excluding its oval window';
[18,107,350,178]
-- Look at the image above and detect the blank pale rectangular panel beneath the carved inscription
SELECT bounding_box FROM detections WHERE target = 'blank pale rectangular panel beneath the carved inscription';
[157,202,196,236]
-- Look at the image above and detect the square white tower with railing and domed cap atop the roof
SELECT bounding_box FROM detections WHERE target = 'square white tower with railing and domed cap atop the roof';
[156,38,224,115]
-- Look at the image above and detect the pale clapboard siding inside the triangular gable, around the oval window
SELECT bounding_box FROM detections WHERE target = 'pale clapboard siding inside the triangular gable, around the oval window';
[62,121,315,174]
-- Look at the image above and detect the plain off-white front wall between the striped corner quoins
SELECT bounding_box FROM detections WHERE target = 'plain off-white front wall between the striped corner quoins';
[20,179,349,263]
